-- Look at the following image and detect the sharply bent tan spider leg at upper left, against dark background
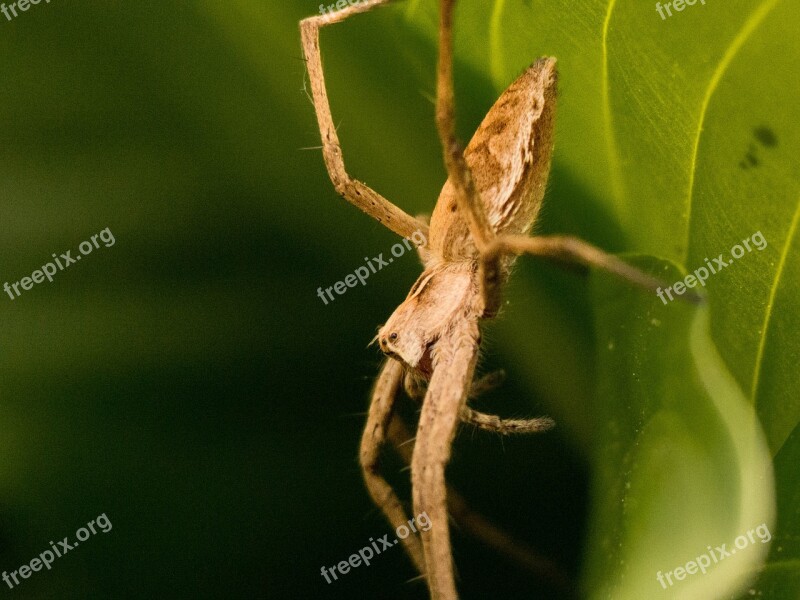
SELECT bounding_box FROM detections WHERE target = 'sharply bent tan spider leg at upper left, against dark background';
[300,0,428,240]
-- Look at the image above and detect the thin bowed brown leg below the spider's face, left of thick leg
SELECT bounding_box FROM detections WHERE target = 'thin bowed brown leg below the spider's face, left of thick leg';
[359,358,425,574]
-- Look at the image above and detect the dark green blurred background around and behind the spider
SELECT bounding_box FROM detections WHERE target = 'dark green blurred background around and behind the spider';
[0,0,616,598]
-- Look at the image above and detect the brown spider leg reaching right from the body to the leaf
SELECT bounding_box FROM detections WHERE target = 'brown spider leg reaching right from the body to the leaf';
[480,235,700,312]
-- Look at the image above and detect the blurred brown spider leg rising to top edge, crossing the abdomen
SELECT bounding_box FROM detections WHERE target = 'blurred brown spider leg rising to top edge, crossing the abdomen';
[436,0,494,250]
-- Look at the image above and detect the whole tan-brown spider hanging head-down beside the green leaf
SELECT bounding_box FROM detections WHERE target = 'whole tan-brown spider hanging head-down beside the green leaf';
[300,0,659,600]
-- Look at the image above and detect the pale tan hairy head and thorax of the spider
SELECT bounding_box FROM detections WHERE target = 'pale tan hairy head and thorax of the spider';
[377,265,474,379]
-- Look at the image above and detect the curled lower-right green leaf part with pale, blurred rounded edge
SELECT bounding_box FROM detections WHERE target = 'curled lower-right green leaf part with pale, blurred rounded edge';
[584,266,774,600]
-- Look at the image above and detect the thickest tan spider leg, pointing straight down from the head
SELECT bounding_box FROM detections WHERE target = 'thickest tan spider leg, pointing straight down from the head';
[411,321,480,600]
